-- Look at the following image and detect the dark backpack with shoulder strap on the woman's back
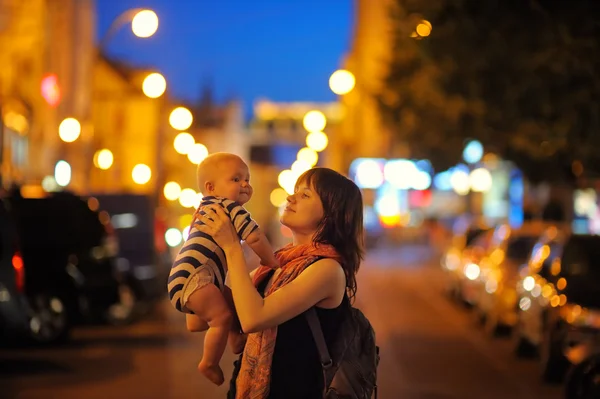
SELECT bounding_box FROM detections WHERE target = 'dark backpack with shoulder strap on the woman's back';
[305,258,379,399]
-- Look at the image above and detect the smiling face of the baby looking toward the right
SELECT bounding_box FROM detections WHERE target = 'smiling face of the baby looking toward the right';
[211,158,252,205]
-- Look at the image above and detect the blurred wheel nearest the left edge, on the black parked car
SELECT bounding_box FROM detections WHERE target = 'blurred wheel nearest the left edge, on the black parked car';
[29,292,71,345]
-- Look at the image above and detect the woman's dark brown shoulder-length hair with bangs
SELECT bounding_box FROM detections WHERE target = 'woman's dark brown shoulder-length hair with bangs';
[298,168,364,299]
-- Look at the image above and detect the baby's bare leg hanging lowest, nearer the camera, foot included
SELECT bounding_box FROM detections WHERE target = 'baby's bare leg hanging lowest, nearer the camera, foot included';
[185,284,232,385]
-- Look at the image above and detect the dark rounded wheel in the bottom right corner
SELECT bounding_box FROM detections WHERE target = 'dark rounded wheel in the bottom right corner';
[565,356,600,399]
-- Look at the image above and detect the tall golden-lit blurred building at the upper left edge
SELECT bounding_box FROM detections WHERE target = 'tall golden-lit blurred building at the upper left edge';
[0,0,95,188]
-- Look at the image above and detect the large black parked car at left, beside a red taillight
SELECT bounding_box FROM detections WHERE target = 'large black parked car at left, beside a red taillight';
[3,193,128,344]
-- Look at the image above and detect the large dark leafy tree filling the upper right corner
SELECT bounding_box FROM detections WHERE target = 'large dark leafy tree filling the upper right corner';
[378,0,600,182]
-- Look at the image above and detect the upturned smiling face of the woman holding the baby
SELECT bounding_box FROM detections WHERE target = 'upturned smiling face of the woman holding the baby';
[281,182,323,234]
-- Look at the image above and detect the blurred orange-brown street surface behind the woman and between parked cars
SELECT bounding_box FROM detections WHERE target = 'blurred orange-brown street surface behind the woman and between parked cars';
[0,247,562,399]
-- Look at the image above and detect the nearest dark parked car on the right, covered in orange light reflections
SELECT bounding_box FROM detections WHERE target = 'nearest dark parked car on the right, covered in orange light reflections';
[515,228,600,382]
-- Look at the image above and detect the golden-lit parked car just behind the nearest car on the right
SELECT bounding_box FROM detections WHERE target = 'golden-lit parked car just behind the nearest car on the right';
[472,222,545,334]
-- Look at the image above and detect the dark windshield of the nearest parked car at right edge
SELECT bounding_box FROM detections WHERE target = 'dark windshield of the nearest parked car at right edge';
[560,236,600,307]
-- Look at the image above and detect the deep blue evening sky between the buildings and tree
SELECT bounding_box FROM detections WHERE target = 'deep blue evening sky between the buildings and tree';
[96,0,354,114]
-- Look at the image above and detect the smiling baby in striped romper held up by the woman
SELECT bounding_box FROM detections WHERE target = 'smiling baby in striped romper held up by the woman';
[168,153,278,385]
